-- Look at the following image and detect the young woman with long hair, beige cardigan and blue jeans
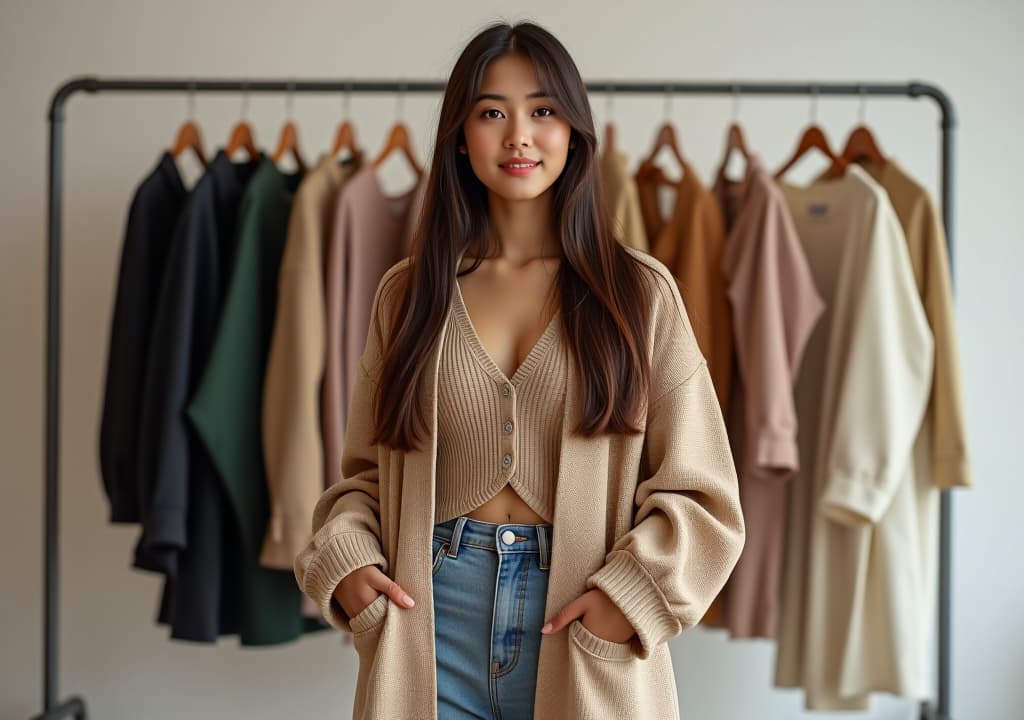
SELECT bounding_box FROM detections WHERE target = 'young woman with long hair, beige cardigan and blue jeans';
[295,23,743,720]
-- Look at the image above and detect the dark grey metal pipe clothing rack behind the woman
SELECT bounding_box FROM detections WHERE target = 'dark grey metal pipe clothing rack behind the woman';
[36,77,955,720]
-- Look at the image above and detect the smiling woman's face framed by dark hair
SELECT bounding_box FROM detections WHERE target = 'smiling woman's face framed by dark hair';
[463,54,571,200]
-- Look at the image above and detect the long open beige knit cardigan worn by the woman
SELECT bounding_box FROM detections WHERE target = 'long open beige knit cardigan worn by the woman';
[295,249,743,720]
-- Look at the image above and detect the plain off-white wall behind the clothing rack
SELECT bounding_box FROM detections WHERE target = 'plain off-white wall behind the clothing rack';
[0,0,1024,720]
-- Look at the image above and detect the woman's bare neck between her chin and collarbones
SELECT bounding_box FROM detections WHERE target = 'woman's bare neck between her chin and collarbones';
[487,189,561,262]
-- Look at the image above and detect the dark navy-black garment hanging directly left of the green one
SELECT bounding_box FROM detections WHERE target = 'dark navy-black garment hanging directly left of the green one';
[135,151,261,642]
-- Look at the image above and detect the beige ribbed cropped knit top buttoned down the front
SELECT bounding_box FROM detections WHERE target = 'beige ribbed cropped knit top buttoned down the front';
[434,276,568,522]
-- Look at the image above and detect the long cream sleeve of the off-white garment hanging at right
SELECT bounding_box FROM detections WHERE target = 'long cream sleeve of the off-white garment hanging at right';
[821,198,934,525]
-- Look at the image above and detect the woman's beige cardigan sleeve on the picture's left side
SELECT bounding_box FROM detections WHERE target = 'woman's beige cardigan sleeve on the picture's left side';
[294,263,402,632]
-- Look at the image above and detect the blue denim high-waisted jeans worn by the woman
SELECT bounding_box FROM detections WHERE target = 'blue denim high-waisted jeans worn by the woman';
[433,516,551,720]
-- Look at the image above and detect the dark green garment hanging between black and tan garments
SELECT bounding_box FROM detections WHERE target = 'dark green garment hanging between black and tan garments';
[187,159,325,645]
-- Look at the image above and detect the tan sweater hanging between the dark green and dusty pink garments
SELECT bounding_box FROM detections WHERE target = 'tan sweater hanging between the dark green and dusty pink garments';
[260,151,359,569]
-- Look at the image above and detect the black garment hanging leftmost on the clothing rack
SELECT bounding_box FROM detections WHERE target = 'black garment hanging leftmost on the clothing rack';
[99,152,188,522]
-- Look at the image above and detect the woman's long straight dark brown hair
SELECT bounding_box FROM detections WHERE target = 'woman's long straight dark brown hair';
[373,23,650,451]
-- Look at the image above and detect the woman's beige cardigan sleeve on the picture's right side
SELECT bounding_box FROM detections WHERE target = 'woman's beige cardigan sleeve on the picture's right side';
[587,259,744,659]
